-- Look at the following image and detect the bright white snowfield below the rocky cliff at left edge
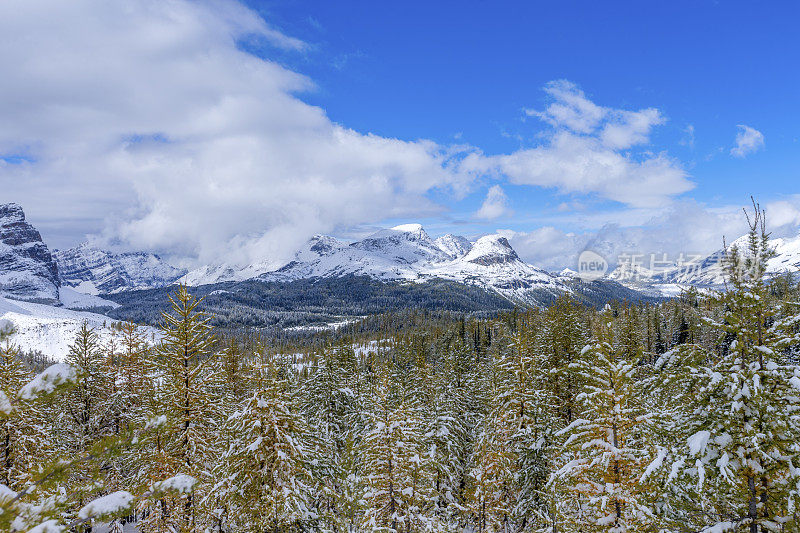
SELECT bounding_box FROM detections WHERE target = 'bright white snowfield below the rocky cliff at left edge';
[0,297,158,361]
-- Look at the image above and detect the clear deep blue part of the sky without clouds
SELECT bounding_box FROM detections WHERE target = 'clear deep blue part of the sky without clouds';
[248,1,800,211]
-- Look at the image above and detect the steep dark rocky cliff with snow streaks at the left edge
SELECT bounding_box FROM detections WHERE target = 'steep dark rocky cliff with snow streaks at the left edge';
[0,203,60,302]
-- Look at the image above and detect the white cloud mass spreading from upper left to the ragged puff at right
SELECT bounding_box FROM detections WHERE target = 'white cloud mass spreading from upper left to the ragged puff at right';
[0,0,692,266]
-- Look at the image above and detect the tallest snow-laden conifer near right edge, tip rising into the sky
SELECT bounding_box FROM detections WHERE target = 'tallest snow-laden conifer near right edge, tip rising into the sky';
[659,202,800,533]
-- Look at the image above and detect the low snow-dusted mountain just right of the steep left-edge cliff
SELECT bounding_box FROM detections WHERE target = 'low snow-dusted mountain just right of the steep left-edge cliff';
[54,243,186,294]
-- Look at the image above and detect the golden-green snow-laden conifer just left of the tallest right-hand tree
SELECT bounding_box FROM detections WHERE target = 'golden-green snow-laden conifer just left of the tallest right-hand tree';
[552,312,663,533]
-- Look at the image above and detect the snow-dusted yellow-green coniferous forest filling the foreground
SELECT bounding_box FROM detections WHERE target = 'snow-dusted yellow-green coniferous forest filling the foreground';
[0,213,800,533]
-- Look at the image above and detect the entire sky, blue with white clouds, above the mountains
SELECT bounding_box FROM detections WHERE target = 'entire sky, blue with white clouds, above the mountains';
[0,0,800,269]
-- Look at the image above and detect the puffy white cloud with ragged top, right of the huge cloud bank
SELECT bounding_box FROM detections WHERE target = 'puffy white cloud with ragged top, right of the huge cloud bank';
[464,81,694,207]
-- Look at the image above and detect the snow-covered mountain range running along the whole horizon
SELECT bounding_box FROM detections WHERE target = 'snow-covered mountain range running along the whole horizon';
[6,203,800,314]
